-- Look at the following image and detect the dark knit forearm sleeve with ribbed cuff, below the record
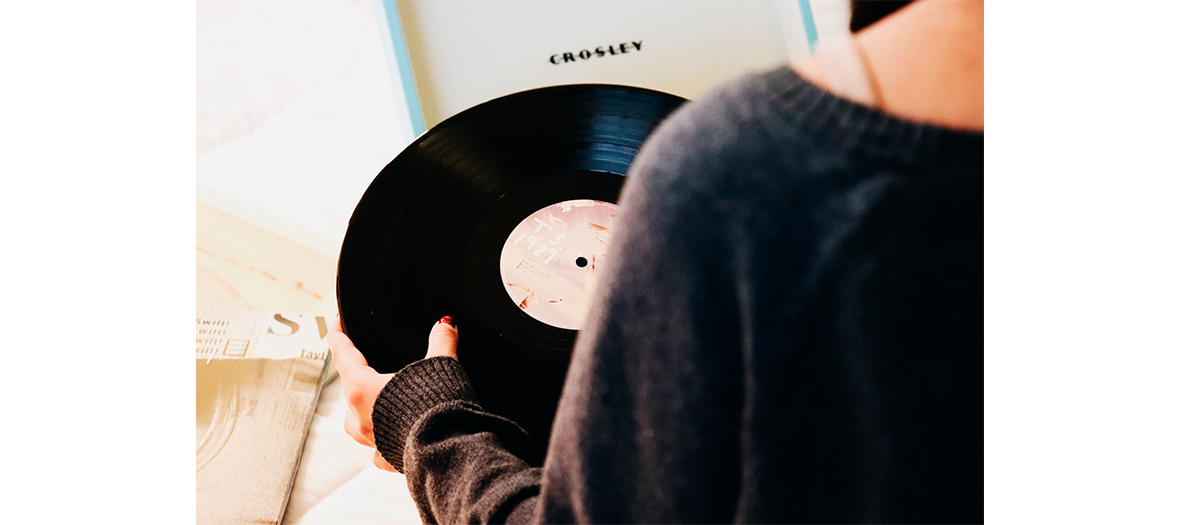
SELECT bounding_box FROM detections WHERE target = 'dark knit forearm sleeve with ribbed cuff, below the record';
[373,357,540,524]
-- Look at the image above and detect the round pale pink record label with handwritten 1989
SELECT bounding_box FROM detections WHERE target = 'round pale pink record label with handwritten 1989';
[500,199,618,330]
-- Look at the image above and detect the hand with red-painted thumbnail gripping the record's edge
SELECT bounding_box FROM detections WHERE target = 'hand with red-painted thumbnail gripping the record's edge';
[328,316,459,472]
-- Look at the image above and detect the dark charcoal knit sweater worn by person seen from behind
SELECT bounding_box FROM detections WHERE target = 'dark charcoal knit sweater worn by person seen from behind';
[373,68,983,524]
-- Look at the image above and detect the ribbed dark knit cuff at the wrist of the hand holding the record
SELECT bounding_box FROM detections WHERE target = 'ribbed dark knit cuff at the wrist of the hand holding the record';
[373,357,476,472]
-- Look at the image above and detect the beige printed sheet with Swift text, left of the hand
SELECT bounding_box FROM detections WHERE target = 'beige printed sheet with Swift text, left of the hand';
[196,308,328,524]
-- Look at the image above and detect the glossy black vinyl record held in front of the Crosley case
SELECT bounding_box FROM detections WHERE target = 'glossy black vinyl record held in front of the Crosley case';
[336,85,684,461]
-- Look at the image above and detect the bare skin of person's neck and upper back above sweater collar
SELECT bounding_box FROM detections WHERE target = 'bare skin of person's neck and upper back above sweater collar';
[795,0,983,131]
